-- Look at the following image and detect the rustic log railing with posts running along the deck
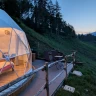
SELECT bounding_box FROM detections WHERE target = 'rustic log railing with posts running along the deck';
[0,52,76,96]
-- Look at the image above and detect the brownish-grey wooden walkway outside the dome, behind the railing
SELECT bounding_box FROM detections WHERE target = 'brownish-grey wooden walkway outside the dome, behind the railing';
[18,60,73,96]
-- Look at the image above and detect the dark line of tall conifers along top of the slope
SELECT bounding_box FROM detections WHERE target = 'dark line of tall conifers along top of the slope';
[0,0,76,38]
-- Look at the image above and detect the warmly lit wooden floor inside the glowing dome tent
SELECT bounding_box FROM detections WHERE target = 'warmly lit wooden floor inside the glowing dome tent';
[0,64,30,87]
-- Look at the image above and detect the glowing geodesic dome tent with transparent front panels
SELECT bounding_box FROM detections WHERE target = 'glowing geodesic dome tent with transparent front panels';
[0,9,32,85]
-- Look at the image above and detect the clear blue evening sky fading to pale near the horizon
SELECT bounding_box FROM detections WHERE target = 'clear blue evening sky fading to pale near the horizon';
[52,0,96,34]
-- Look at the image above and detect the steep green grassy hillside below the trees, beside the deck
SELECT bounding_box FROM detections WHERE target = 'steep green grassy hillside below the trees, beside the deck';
[20,20,96,96]
